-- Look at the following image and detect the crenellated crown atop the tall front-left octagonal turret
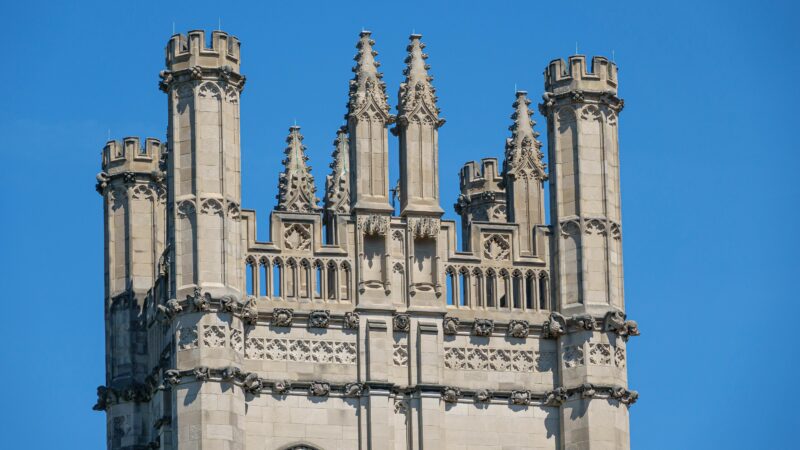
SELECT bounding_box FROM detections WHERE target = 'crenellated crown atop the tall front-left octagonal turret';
[166,30,241,73]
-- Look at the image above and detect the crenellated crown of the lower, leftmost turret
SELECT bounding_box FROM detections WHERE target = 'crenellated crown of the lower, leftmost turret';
[103,137,165,176]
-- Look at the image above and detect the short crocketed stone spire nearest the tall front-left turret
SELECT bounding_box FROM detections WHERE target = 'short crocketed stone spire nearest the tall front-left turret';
[275,125,319,212]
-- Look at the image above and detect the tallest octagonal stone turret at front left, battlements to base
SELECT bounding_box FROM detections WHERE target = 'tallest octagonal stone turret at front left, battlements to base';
[161,31,244,449]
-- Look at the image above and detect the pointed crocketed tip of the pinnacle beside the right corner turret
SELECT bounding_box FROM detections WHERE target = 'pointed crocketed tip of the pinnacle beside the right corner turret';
[505,91,547,180]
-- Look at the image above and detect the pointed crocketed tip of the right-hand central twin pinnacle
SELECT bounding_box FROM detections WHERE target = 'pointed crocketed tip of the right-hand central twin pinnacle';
[397,34,444,128]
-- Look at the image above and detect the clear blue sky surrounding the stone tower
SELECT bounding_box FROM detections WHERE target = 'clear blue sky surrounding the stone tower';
[0,0,800,449]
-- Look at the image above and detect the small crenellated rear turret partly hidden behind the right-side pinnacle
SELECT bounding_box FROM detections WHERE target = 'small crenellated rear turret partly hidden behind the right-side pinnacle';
[453,158,506,251]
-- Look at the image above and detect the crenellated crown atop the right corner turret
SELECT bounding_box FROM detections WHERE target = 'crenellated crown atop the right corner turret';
[544,55,617,94]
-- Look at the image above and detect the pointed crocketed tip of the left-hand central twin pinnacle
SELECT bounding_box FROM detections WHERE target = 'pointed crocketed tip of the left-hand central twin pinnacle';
[345,31,394,123]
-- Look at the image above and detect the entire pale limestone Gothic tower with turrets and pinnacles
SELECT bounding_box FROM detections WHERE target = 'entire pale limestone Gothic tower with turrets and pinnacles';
[95,31,638,450]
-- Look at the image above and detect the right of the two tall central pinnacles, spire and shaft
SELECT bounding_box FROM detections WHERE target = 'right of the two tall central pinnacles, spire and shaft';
[392,34,445,216]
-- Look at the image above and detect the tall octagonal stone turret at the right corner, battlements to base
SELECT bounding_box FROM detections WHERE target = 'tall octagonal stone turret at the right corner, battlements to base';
[541,55,637,448]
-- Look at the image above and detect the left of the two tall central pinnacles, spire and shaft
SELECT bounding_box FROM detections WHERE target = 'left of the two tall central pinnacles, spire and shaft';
[345,31,395,213]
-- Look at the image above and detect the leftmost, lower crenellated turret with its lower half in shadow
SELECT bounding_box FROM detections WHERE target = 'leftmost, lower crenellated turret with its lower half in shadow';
[97,137,166,449]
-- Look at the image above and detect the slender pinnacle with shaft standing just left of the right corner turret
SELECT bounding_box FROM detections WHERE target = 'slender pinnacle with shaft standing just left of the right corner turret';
[503,91,547,255]
